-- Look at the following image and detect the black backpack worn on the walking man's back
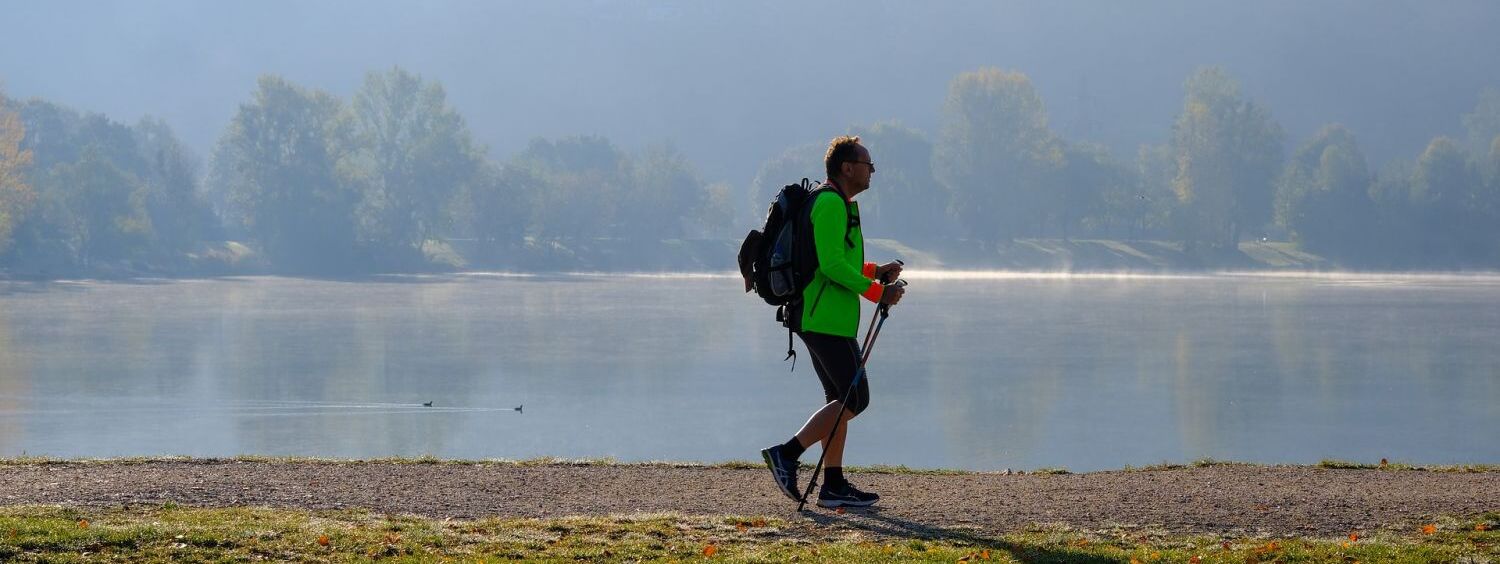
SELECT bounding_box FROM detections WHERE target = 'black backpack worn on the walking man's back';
[740,179,852,369]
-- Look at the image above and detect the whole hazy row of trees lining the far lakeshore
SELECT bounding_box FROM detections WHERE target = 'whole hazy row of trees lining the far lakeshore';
[0,68,1500,276]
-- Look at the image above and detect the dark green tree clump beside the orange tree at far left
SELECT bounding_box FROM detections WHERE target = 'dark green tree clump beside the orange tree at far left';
[6,94,218,270]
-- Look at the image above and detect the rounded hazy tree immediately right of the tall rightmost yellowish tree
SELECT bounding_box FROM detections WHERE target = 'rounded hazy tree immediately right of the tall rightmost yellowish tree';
[1275,125,1376,257]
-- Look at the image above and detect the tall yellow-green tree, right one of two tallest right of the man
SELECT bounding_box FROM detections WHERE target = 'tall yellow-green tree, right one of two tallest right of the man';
[1172,68,1283,249]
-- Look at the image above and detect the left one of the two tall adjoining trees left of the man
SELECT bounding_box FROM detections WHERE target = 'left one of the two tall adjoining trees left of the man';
[213,75,359,270]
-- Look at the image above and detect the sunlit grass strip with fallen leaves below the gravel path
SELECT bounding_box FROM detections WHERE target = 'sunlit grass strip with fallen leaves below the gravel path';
[0,504,1500,563]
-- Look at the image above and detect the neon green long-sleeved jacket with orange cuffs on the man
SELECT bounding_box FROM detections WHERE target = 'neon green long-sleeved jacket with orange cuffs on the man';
[803,185,884,338]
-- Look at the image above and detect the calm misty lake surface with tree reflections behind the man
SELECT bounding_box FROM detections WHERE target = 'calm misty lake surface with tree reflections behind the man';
[0,273,1500,471]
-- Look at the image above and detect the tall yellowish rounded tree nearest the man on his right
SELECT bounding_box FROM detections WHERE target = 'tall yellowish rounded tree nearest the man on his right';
[933,69,1064,243]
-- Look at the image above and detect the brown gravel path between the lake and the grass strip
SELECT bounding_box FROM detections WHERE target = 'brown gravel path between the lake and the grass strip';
[0,461,1500,537]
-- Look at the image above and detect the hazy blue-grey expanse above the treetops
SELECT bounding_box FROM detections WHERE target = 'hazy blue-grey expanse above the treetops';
[0,0,1500,186]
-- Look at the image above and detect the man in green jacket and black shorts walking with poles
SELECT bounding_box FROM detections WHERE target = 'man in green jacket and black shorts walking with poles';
[761,137,905,507]
